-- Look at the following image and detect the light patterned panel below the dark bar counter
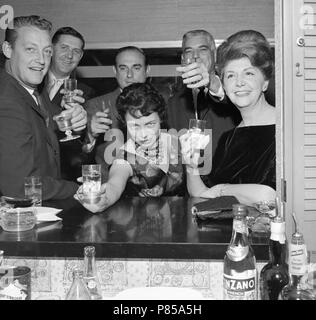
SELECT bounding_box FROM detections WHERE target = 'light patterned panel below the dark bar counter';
[4,257,264,300]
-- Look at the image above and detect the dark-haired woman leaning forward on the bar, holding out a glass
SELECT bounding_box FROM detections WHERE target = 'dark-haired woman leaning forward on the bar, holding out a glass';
[75,83,184,212]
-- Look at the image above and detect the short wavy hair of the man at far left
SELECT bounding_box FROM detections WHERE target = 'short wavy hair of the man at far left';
[4,15,52,47]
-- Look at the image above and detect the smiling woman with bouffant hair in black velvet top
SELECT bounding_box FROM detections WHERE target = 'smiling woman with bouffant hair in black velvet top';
[180,30,276,205]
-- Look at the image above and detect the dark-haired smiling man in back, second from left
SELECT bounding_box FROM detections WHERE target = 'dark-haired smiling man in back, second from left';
[45,27,95,181]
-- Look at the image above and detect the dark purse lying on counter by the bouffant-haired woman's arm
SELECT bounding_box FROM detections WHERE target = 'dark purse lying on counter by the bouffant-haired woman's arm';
[191,196,239,220]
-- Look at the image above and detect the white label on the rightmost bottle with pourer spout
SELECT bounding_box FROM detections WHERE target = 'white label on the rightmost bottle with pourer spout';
[289,243,307,276]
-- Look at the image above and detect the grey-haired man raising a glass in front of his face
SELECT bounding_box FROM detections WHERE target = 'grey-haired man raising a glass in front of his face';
[167,30,240,174]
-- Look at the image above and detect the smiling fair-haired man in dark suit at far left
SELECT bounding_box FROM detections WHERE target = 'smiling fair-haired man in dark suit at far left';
[0,16,87,200]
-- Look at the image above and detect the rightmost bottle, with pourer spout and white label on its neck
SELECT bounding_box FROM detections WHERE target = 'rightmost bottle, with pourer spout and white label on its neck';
[279,230,315,300]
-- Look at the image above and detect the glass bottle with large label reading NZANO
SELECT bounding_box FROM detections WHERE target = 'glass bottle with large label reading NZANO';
[223,204,257,300]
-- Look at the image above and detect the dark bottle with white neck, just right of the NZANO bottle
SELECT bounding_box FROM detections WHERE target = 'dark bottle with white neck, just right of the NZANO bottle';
[260,216,289,300]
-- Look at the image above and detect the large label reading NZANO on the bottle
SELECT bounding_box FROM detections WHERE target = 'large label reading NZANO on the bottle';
[223,269,257,300]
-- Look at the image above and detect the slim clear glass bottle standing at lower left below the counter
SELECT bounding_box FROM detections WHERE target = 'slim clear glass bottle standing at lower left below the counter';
[83,246,102,300]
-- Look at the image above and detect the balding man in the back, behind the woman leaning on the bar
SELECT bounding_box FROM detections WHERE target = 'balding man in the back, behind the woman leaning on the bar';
[85,46,149,179]
